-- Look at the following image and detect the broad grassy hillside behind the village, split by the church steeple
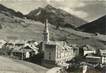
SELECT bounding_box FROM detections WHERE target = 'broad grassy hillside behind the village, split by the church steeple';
[0,4,105,48]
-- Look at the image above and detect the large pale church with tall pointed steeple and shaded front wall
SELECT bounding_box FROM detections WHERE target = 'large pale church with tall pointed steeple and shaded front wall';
[42,20,75,66]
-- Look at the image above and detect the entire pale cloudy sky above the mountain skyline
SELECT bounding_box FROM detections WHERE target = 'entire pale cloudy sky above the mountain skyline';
[0,0,106,21]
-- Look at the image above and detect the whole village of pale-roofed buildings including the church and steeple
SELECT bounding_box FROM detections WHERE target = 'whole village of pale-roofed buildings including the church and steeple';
[0,19,106,73]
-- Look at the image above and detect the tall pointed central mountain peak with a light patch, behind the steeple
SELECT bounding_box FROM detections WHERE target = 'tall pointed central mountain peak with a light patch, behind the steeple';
[27,5,87,28]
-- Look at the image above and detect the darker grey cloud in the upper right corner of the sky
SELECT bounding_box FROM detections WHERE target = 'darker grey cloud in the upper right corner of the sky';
[74,1,106,21]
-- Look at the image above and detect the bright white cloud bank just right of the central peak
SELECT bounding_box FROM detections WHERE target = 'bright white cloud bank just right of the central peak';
[47,0,88,18]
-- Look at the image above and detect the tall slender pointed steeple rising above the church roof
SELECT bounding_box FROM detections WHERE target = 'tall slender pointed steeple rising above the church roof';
[43,19,49,43]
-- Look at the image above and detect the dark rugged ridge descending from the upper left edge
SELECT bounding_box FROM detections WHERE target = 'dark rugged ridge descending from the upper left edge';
[0,4,24,18]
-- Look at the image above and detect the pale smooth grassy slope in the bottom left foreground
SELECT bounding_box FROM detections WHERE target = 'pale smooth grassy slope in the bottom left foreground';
[0,56,48,73]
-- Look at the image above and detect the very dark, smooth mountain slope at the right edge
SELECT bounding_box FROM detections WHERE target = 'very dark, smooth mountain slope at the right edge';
[78,15,106,35]
